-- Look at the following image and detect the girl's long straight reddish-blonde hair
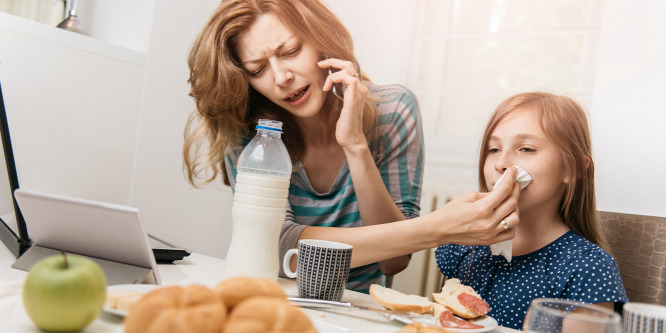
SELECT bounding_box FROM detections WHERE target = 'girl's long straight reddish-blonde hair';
[479,92,608,249]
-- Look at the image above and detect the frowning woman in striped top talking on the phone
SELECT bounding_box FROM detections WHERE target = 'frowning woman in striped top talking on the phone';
[184,0,517,292]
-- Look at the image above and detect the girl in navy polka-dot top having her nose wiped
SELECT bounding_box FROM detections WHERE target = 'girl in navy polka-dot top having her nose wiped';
[436,92,627,329]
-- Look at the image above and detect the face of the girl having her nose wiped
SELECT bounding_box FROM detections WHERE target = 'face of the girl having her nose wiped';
[483,109,568,215]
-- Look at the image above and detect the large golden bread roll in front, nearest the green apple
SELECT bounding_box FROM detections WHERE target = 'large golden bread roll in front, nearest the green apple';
[125,285,227,333]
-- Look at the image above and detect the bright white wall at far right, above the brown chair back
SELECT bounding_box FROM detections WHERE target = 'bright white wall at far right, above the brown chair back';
[591,0,666,216]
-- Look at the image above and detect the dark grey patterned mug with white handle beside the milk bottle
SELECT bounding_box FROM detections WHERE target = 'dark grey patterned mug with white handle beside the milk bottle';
[282,239,352,301]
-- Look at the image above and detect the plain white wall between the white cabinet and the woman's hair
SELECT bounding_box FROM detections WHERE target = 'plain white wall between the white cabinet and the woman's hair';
[131,0,232,258]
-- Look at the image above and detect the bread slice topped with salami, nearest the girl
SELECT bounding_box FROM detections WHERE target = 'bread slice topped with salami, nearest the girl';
[432,279,490,319]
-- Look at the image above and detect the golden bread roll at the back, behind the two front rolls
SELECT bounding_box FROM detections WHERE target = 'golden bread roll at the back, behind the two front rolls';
[214,277,287,310]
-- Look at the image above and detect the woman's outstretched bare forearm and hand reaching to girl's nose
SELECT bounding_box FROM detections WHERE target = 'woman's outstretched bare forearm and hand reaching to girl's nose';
[291,169,520,269]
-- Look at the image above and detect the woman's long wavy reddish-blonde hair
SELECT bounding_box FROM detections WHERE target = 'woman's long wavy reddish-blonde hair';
[183,0,374,186]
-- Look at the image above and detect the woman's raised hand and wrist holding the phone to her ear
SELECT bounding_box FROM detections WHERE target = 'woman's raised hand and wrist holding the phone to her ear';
[318,59,370,149]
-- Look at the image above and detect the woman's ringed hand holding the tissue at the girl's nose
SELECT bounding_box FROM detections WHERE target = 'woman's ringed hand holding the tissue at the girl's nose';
[428,168,520,246]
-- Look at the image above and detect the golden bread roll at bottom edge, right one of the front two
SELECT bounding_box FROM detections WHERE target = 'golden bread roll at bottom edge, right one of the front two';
[224,296,317,333]
